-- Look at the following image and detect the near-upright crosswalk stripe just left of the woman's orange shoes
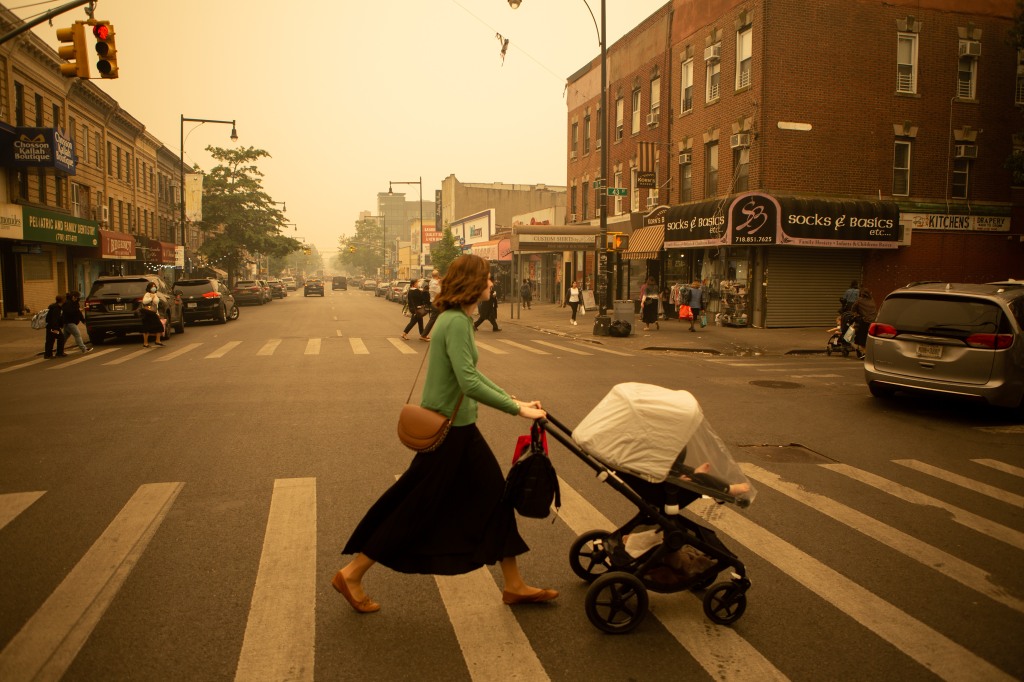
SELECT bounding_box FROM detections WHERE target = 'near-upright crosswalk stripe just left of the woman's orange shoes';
[234,478,316,681]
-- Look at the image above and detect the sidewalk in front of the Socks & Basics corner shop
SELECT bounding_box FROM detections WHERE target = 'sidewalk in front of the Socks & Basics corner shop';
[497,301,828,355]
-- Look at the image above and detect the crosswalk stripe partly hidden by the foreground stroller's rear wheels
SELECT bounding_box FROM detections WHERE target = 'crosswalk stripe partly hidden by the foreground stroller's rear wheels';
[558,478,786,682]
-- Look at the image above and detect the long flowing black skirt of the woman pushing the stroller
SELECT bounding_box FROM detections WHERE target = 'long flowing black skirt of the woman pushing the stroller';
[342,424,529,576]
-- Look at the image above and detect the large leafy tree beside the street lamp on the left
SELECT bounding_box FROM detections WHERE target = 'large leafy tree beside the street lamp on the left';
[200,146,300,282]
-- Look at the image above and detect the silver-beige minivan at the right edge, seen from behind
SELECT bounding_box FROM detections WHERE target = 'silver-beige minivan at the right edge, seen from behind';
[864,282,1024,417]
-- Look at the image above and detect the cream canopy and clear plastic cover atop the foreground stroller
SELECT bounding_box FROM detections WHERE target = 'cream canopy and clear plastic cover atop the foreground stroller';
[572,383,756,503]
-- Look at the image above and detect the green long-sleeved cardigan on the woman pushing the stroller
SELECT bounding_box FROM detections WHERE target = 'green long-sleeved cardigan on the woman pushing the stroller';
[420,309,519,426]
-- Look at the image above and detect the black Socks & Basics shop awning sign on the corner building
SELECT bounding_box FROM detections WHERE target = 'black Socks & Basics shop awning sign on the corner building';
[665,191,899,249]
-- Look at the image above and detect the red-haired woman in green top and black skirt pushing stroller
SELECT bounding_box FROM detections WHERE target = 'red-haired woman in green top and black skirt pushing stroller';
[331,255,558,613]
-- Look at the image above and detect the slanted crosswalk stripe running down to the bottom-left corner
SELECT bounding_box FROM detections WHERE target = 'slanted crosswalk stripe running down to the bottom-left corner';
[0,483,183,682]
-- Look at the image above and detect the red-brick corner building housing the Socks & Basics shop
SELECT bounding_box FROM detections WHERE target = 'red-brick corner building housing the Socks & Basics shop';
[567,0,1024,327]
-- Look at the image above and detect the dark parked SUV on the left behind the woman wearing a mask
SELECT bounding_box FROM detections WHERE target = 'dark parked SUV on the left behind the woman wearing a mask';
[83,274,185,346]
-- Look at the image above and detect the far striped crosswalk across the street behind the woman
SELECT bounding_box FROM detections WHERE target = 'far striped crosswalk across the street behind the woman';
[0,331,635,374]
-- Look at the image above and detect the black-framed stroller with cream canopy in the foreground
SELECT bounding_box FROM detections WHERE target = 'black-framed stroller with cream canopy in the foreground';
[542,383,756,634]
